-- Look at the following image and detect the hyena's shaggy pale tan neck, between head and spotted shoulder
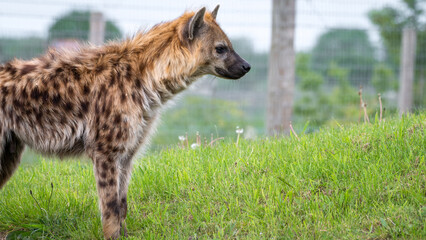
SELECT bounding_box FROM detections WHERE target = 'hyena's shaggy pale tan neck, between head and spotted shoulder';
[129,22,202,103]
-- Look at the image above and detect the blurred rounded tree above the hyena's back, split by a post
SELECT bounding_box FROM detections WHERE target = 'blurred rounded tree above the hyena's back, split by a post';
[49,10,121,41]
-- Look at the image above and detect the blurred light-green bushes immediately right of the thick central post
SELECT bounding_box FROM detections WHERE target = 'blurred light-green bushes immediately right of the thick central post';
[294,58,359,129]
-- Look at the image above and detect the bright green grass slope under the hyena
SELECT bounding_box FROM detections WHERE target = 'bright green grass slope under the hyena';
[0,114,426,239]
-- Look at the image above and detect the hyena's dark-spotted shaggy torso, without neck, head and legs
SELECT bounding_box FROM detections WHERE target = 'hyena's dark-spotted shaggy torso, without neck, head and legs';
[0,46,141,159]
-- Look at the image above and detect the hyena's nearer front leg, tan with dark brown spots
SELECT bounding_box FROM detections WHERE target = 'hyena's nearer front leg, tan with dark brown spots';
[92,147,121,239]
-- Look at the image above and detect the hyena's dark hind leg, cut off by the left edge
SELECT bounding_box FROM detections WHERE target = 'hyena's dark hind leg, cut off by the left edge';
[0,129,25,189]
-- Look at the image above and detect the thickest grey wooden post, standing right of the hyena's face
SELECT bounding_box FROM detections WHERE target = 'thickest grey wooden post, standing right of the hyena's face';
[267,0,296,136]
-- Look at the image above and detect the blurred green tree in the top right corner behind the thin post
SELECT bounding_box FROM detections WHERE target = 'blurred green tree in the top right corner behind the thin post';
[368,0,426,107]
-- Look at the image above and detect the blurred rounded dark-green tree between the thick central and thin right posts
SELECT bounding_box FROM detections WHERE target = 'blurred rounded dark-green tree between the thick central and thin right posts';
[311,29,375,85]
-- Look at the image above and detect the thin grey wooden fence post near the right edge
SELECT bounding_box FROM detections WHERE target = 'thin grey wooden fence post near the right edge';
[398,28,417,115]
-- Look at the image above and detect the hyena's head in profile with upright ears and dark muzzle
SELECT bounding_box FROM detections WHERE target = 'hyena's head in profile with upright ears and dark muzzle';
[182,5,251,79]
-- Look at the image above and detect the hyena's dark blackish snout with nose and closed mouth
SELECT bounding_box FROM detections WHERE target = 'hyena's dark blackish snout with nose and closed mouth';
[215,51,251,79]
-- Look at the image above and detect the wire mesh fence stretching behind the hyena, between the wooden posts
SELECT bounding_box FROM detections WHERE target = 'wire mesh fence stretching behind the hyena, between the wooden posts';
[0,0,426,146]
